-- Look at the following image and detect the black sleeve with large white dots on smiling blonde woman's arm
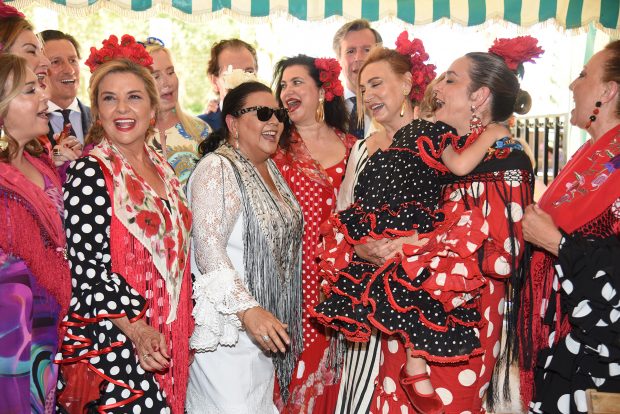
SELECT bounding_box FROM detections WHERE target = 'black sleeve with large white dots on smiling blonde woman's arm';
[63,157,146,319]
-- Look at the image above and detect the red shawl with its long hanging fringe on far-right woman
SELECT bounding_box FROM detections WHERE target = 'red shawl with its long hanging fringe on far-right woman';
[520,124,620,404]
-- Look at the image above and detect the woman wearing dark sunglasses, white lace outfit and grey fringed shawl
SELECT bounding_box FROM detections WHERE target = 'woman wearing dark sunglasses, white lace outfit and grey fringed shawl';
[186,82,303,414]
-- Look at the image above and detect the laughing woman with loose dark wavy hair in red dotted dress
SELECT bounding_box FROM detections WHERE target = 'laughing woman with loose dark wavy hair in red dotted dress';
[273,55,356,413]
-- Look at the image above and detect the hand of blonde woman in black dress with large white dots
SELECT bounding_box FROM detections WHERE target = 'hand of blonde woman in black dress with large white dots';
[125,320,170,372]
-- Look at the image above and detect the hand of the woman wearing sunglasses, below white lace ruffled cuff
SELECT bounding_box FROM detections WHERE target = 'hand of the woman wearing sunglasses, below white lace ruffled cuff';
[242,306,291,352]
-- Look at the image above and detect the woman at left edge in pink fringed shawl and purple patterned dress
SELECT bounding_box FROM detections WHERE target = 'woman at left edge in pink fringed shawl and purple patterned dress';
[0,54,71,414]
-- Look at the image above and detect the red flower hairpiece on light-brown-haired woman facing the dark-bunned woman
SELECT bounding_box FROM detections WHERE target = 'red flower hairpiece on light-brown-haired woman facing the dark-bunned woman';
[396,30,436,102]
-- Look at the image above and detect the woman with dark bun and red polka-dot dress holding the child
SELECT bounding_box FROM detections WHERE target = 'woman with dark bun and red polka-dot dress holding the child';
[404,43,542,413]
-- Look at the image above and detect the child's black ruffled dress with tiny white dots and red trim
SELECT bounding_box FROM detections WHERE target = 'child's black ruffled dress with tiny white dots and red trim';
[312,120,481,362]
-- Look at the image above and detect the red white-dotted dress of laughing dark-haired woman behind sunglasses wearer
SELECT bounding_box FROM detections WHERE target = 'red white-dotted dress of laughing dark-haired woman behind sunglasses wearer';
[274,130,356,414]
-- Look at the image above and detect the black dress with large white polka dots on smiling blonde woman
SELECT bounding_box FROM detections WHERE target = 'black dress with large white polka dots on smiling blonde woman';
[57,158,170,413]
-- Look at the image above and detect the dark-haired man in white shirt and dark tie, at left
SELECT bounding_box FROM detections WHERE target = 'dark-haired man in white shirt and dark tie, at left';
[40,30,92,146]
